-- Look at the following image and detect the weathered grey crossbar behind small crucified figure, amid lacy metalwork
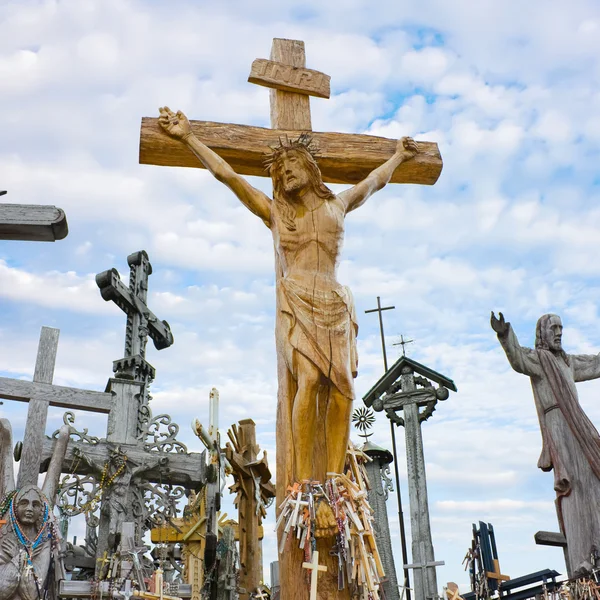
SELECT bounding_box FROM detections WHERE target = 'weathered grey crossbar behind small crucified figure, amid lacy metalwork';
[41,438,206,489]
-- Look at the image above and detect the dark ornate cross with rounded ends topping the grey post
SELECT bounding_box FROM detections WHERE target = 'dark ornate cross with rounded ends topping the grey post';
[96,250,173,381]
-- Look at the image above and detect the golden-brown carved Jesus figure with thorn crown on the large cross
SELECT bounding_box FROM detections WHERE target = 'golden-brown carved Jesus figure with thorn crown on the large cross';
[159,107,417,483]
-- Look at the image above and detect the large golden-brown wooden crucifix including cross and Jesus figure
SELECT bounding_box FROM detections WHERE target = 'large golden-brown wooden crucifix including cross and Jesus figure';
[140,39,442,600]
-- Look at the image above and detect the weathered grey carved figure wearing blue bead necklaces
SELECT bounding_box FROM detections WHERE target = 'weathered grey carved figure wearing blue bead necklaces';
[0,419,69,600]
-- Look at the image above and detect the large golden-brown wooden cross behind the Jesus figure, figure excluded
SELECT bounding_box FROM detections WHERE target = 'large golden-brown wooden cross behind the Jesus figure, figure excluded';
[140,39,442,600]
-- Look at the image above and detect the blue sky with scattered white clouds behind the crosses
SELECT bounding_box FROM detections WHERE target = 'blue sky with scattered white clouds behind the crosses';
[0,0,600,589]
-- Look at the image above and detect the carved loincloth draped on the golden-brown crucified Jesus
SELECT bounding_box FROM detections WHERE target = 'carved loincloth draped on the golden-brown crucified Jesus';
[277,278,358,400]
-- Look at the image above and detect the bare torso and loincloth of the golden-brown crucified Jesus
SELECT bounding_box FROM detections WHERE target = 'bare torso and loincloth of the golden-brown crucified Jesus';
[271,197,358,400]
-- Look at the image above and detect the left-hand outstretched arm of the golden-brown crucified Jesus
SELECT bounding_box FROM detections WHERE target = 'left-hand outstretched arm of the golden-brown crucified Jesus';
[158,106,271,227]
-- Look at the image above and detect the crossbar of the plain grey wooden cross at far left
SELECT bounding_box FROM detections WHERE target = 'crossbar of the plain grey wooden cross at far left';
[0,377,113,414]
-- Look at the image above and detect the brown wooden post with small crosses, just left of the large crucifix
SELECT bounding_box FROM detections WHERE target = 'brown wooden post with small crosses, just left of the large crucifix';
[225,419,275,600]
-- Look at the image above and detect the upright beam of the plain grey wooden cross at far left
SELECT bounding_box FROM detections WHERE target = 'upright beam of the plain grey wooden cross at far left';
[17,327,60,488]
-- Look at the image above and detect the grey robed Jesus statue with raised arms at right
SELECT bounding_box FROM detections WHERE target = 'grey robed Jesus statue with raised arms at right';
[490,312,600,576]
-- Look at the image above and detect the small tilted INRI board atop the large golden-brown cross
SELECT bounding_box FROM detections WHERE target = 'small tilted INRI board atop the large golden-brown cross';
[248,58,331,98]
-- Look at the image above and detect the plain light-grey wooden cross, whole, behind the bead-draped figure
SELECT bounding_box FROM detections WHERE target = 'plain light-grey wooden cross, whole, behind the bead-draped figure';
[0,327,113,488]
